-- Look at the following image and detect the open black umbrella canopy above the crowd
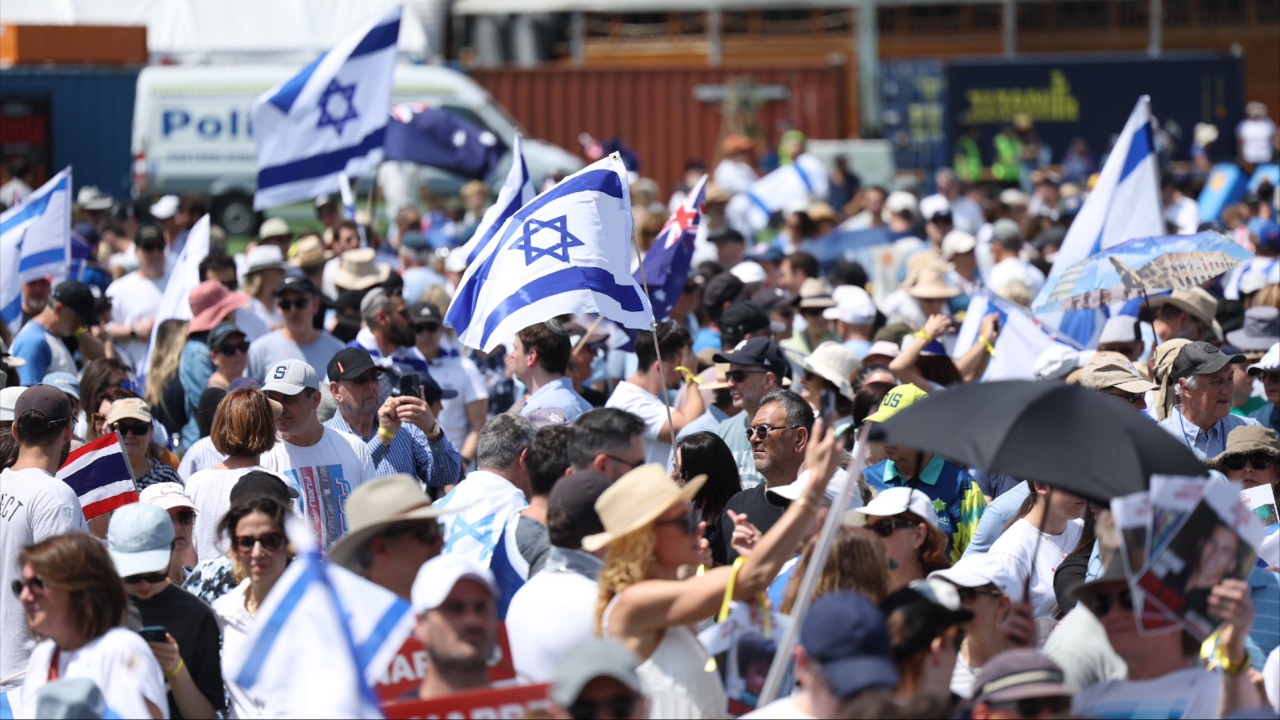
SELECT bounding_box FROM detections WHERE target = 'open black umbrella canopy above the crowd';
[870,380,1204,502]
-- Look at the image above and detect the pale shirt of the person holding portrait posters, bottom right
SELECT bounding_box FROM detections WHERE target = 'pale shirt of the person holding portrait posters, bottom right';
[1071,667,1222,720]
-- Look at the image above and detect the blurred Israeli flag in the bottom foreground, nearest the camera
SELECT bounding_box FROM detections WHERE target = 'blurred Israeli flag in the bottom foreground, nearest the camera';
[223,514,413,717]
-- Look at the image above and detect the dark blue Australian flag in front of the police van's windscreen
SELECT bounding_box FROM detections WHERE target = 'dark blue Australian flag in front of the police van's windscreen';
[383,102,507,179]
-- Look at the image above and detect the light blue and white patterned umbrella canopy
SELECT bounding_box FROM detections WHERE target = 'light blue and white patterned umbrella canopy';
[1032,232,1253,313]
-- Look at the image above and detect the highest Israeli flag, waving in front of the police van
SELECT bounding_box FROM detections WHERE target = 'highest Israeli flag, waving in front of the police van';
[252,4,401,210]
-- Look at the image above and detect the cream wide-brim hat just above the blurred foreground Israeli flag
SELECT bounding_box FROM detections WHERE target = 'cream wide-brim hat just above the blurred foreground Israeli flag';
[329,474,462,573]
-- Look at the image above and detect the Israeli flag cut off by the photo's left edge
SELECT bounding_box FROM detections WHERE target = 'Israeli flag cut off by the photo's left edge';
[0,167,72,333]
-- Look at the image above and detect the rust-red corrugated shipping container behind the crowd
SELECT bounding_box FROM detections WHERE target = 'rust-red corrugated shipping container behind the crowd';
[471,64,849,200]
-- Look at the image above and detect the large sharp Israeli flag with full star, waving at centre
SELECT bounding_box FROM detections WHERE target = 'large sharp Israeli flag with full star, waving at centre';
[444,152,653,352]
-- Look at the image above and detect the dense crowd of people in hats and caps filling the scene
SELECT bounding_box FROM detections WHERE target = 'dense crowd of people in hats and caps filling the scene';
[0,117,1280,717]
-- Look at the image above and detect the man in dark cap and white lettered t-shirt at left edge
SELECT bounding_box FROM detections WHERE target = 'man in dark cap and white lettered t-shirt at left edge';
[0,384,88,692]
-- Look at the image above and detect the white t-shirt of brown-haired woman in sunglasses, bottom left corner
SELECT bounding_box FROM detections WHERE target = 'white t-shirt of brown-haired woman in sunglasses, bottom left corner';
[14,628,169,717]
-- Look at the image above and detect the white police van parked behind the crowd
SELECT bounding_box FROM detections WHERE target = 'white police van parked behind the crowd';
[132,65,582,234]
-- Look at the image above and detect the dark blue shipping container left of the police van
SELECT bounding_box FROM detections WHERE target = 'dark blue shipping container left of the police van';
[0,67,141,199]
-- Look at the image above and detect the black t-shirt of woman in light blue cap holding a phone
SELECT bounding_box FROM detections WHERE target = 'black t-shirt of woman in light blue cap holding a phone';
[131,584,227,719]
